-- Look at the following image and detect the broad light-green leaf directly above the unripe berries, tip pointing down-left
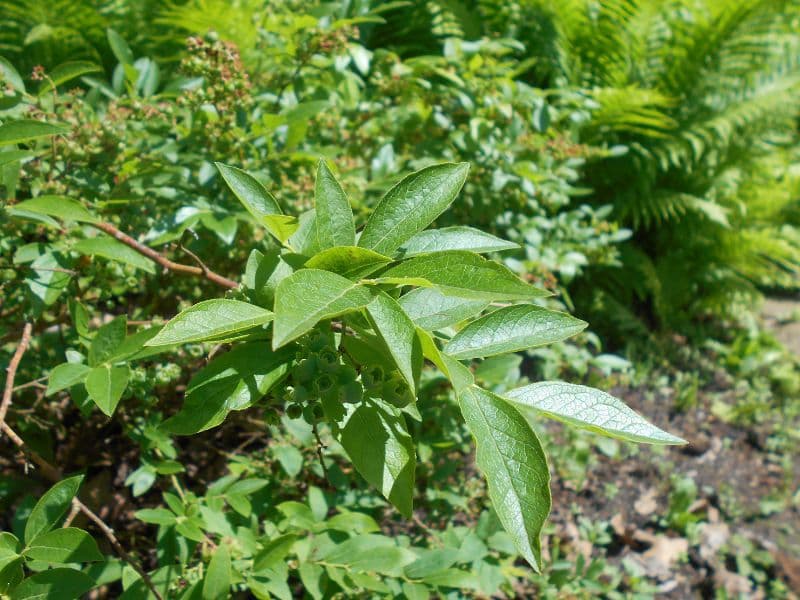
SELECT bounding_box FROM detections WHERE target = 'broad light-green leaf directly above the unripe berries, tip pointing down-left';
[272,269,372,348]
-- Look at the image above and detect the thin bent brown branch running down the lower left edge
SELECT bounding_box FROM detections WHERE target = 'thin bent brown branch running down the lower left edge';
[0,323,163,600]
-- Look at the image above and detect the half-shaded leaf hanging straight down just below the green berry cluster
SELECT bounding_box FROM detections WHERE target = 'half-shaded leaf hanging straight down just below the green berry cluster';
[323,398,416,517]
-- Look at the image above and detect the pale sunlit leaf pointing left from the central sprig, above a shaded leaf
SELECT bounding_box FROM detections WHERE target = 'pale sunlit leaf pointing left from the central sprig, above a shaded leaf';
[145,299,273,346]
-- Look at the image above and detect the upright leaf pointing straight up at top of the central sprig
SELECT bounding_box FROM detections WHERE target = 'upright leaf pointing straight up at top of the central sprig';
[314,160,356,250]
